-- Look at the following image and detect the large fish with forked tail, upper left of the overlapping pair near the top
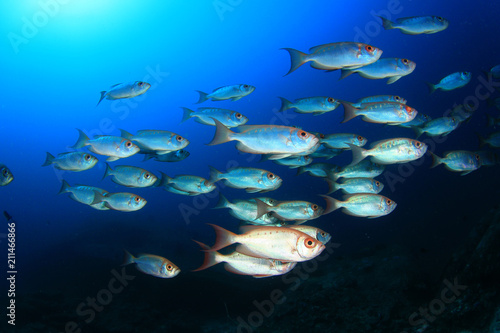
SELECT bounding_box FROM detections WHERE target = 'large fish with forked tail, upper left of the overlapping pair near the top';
[282,42,382,75]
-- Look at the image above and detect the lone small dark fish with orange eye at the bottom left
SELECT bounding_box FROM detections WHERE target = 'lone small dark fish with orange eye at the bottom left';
[122,251,181,279]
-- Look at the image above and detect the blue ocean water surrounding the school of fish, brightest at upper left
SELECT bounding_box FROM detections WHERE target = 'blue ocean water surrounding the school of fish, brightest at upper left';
[0,0,500,332]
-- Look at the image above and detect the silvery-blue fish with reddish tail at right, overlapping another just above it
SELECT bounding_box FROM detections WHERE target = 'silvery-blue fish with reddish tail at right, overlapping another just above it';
[342,102,418,125]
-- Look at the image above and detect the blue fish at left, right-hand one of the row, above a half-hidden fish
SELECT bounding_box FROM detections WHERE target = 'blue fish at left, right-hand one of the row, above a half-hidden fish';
[120,130,189,155]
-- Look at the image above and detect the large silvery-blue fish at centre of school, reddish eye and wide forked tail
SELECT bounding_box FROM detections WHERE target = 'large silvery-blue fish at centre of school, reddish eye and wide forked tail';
[207,119,319,160]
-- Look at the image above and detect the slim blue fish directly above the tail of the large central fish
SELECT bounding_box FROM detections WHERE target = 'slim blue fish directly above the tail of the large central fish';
[181,108,248,128]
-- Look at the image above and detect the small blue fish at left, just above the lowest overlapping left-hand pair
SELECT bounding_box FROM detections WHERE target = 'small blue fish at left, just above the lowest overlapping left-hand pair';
[102,163,158,187]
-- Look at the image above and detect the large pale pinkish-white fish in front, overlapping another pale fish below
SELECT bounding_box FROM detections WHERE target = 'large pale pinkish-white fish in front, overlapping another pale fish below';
[209,224,325,262]
